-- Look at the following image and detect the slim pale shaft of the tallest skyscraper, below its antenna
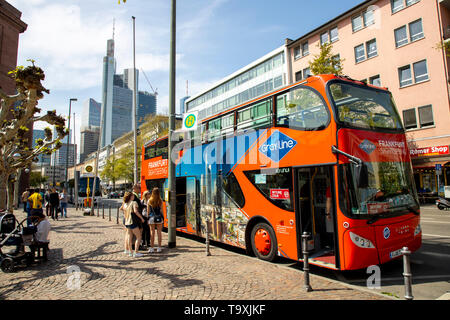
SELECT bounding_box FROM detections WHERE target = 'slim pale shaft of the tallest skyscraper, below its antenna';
[100,39,116,147]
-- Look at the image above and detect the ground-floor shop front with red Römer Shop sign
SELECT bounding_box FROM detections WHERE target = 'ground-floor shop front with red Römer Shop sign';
[410,145,450,203]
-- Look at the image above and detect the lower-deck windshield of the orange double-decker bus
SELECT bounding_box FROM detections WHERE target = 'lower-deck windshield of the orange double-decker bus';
[339,162,419,218]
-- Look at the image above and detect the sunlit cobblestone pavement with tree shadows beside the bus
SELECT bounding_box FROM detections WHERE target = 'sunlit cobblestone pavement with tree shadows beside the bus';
[0,209,388,300]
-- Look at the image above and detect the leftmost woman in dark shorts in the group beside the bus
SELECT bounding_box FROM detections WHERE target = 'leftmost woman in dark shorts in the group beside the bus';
[120,192,145,257]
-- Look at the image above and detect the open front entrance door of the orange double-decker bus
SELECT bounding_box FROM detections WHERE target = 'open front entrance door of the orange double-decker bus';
[296,166,336,269]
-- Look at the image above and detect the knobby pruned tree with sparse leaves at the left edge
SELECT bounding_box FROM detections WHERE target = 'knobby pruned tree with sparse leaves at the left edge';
[0,60,68,212]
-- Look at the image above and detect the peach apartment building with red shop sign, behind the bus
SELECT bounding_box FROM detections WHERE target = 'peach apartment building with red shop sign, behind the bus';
[286,0,450,192]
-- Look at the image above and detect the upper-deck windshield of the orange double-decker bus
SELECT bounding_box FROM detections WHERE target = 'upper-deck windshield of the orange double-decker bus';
[329,82,403,131]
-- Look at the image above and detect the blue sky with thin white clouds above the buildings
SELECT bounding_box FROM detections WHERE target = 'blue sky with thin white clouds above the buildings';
[7,0,363,147]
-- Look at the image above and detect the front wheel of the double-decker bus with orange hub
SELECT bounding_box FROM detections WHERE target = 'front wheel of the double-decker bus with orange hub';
[251,222,278,261]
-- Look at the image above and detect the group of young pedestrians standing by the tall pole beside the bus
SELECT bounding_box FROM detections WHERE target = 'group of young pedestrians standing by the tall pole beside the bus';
[120,184,164,257]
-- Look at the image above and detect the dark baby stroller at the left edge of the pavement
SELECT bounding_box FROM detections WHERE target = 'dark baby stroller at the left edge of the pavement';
[0,212,36,272]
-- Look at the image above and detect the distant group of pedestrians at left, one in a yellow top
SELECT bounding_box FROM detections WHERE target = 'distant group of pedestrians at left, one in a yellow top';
[22,187,69,220]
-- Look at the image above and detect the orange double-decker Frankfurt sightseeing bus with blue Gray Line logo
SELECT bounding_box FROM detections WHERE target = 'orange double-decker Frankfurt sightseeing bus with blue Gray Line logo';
[141,75,422,270]
